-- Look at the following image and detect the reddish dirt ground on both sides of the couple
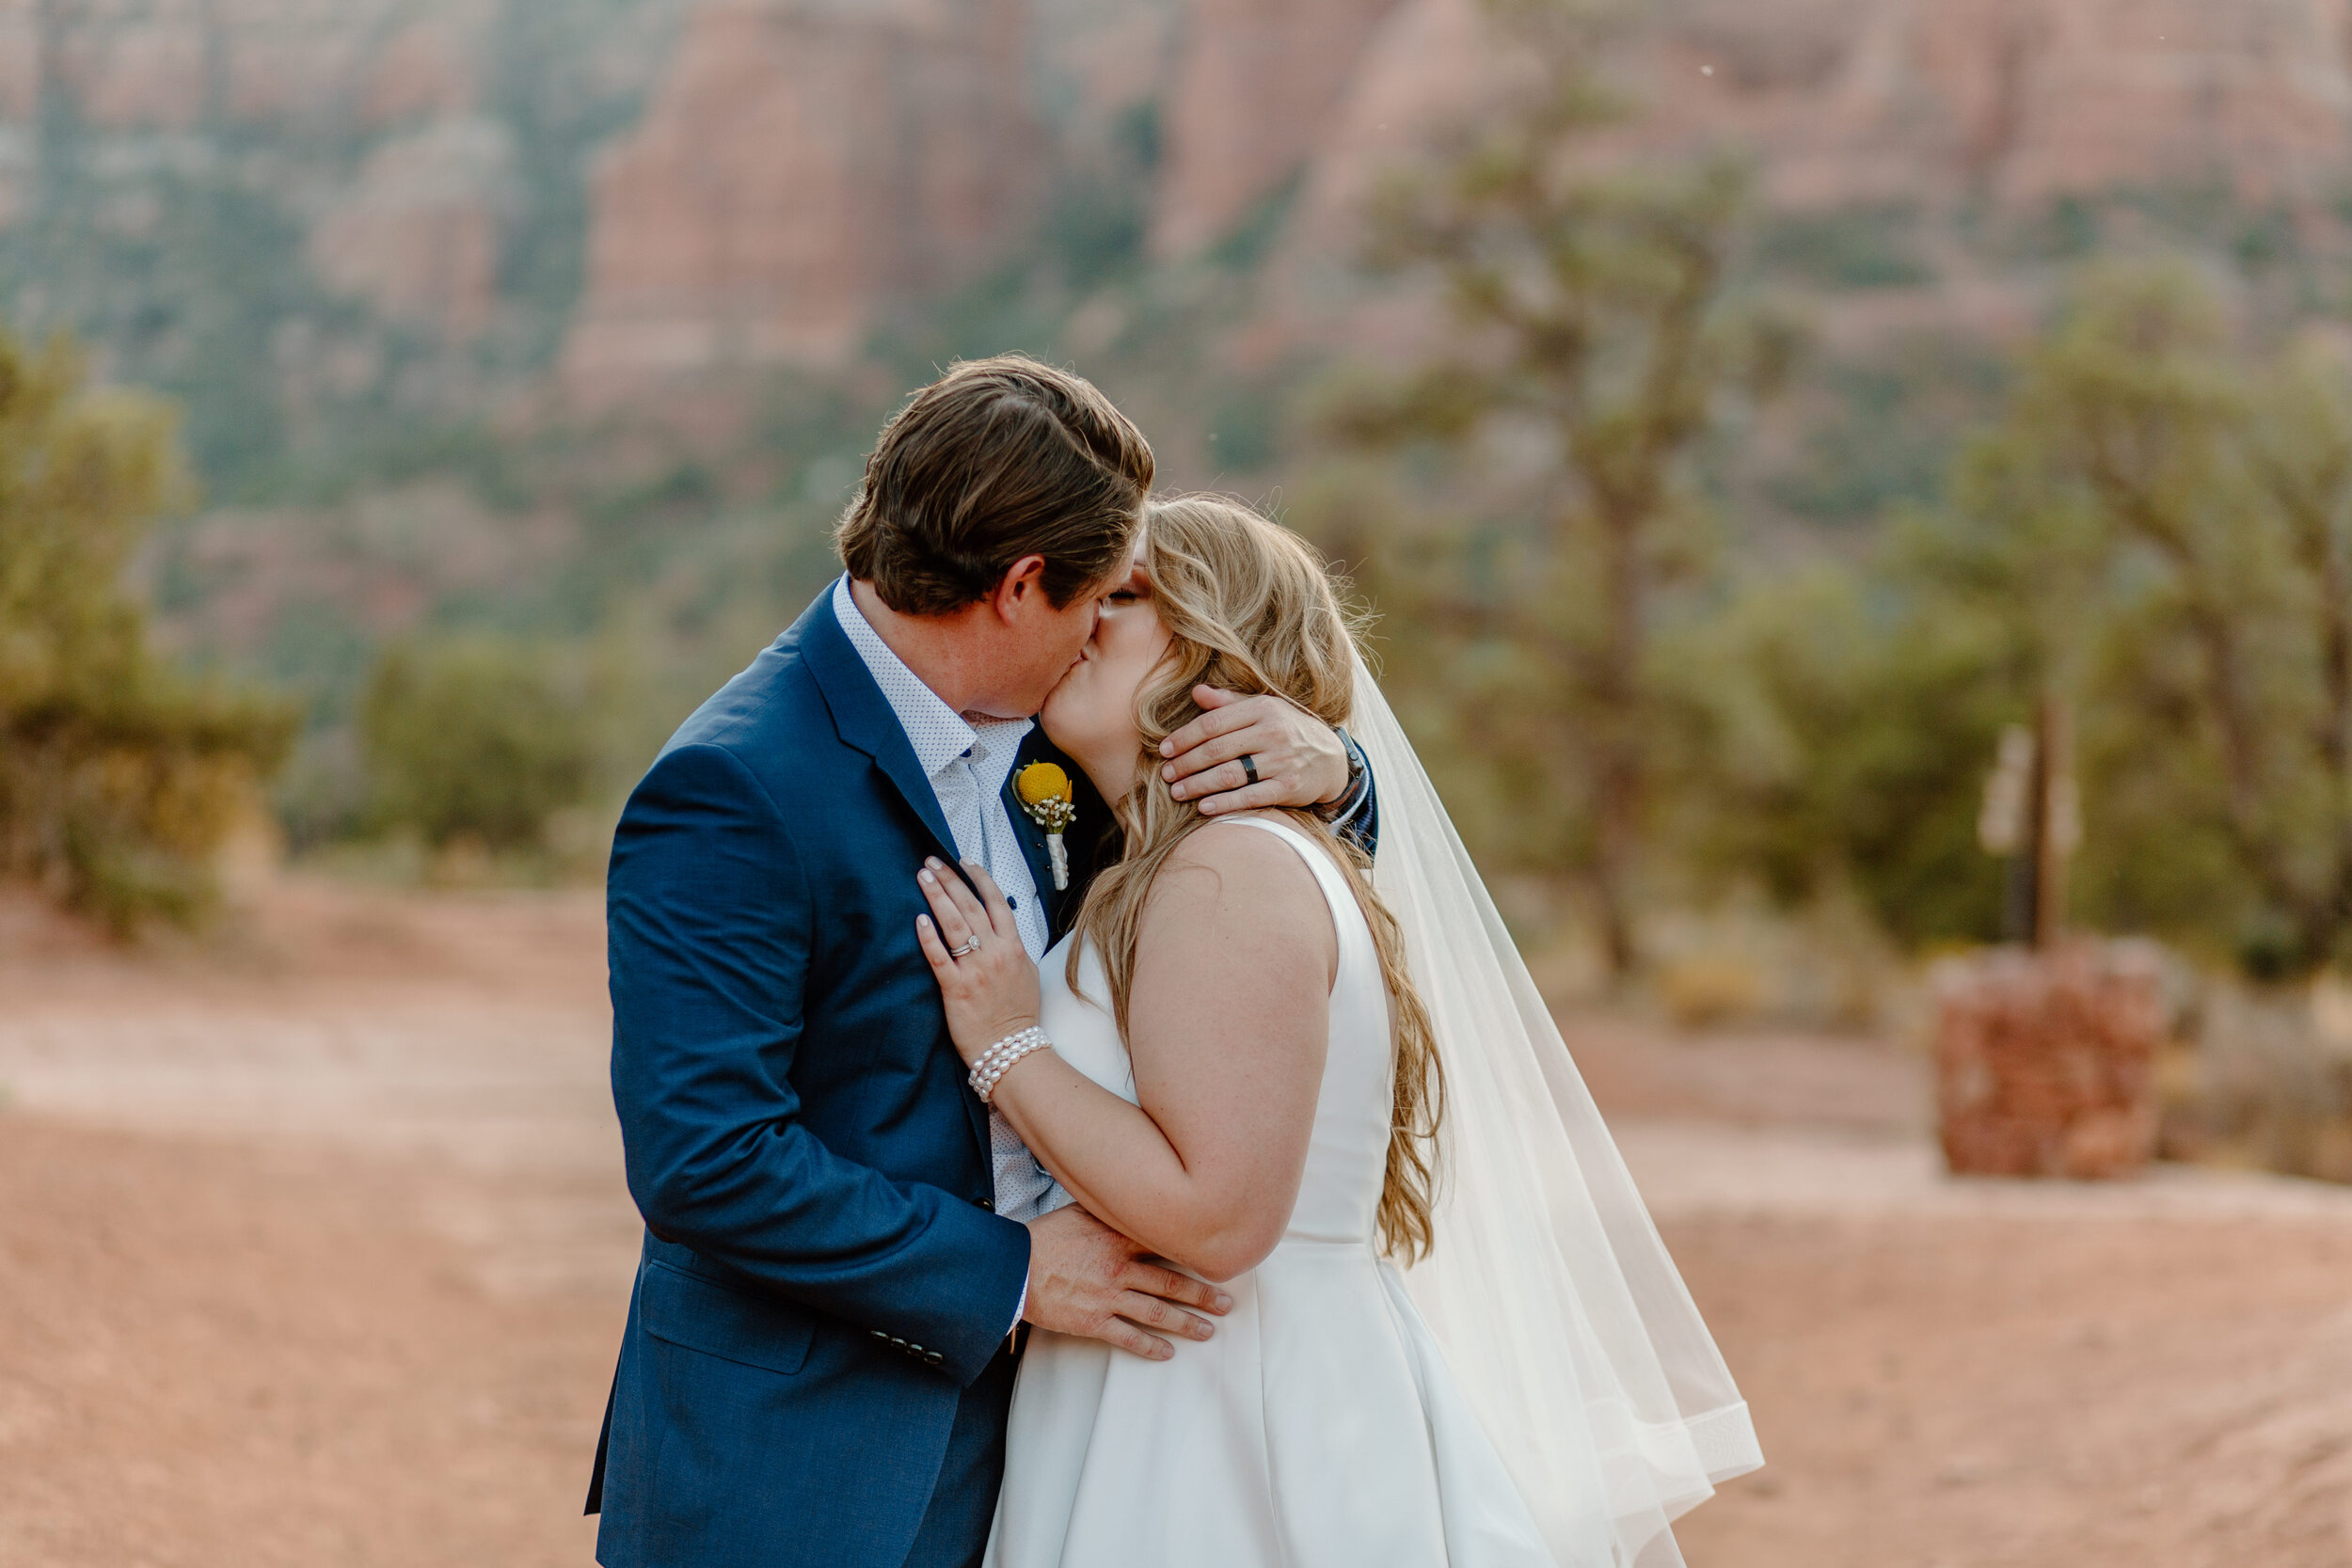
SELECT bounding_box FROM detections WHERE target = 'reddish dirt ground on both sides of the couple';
[0,884,2352,1568]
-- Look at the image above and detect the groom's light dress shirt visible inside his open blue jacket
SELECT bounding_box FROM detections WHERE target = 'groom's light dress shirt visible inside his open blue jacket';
[833,574,1071,1241]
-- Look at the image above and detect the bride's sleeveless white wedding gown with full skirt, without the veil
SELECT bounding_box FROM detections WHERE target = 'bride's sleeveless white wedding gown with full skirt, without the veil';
[988,818,1571,1568]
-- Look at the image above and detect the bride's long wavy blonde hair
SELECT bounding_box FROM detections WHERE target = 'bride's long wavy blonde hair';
[1071,496,1444,1262]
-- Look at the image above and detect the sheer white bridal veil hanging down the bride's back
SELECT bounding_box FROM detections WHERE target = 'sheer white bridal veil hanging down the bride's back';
[1348,660,1764,1568]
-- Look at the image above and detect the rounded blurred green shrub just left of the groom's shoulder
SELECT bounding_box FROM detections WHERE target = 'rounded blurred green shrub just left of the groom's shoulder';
[360,637,596,853]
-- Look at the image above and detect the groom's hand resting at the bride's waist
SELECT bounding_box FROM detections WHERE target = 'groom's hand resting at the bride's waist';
[1021,1206,1232,1361]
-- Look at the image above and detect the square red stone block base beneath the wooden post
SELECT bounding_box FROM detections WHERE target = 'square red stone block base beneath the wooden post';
[1936,942,2167,1178]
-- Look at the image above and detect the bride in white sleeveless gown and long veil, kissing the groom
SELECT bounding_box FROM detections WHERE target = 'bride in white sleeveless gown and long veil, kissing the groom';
[920,499,1762,1568]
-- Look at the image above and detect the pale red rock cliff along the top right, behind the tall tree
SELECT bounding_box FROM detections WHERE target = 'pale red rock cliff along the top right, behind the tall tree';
[1155,0,2352,262]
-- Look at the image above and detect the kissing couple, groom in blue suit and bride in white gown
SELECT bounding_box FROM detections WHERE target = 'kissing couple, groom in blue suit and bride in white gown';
[588,355,1762,1568]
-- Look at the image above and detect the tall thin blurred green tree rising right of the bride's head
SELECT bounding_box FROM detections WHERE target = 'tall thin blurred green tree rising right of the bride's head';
[1331,0,1795,975]
